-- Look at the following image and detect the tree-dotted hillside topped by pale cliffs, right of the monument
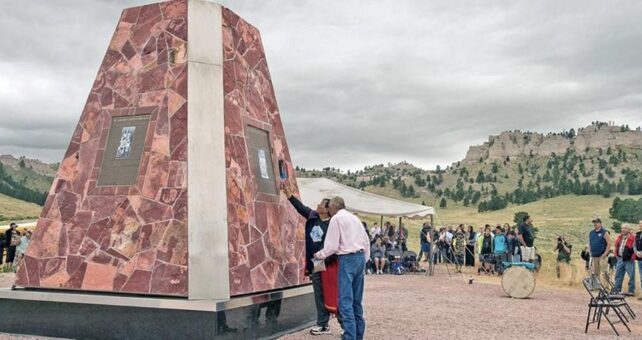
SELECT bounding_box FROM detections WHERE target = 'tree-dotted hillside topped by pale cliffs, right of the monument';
[297,122,642,212]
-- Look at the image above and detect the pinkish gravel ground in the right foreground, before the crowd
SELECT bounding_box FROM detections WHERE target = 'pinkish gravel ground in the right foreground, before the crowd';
[282,268,642,340]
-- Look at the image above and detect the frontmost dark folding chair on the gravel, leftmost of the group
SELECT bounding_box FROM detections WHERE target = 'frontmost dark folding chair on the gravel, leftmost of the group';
[582,278,631,336]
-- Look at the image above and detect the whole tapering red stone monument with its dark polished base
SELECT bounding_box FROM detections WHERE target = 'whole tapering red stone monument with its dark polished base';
[0,0,314,338]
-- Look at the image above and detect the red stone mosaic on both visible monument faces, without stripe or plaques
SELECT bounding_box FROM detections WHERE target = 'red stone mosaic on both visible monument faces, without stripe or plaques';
[16,0,307,296]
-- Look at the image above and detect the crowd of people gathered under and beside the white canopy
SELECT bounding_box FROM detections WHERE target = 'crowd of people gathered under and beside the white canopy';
[364,216,535,275]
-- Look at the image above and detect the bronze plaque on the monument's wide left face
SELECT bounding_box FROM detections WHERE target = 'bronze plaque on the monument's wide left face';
[96,115,150,186]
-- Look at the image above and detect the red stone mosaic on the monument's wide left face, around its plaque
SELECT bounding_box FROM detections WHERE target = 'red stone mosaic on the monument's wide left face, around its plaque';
[16,0,188,296]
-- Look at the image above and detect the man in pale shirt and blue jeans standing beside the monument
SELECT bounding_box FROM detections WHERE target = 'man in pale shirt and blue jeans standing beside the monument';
[314,196,370,340]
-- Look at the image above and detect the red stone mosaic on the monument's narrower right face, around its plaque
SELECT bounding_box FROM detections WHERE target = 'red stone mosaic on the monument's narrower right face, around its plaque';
[223,9,306,295]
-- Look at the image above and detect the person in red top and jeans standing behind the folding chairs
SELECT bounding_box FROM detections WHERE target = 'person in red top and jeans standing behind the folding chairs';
[615,224,635,296]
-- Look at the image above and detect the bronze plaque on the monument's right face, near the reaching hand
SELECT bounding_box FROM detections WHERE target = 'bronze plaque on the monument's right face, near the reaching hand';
[246,126,279,195]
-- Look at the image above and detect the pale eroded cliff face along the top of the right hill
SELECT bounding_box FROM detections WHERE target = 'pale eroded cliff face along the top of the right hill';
[463,125,642,163]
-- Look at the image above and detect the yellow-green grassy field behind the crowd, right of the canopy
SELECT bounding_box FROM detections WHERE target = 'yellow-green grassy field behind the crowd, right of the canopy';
[364,195,637,287]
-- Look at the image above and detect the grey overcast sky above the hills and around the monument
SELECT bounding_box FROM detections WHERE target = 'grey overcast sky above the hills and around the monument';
[0,0,642,169]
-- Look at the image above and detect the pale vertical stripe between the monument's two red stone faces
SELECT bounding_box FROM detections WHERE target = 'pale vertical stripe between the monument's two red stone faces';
[187,0,230,300]
